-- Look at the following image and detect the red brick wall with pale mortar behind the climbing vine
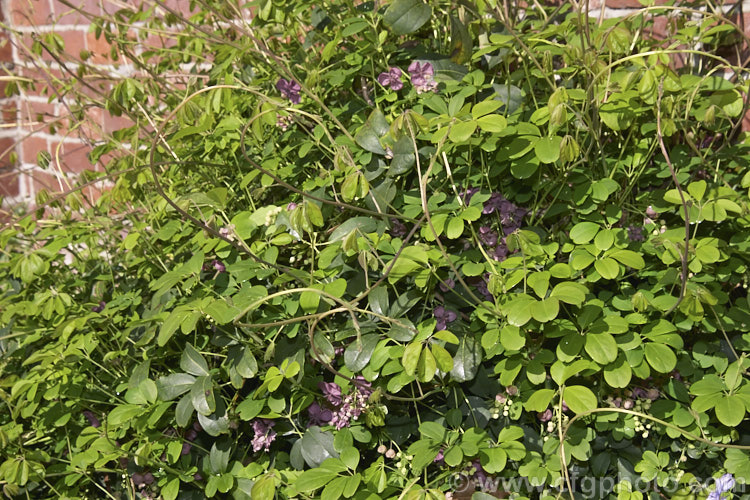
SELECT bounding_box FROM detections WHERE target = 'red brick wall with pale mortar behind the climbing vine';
[0,0,750,206]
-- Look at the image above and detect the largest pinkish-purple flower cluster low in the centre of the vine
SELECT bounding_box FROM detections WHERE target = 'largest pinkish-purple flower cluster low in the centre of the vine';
[307,376,372,430]
